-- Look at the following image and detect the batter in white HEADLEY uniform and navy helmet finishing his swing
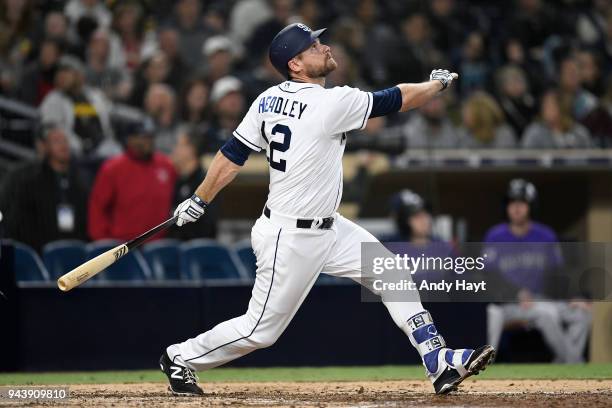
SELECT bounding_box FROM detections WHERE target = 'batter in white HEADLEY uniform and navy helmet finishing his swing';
[160,24,495,395]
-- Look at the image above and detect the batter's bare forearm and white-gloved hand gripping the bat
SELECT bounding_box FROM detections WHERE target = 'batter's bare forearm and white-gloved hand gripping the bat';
[174,152,242,227]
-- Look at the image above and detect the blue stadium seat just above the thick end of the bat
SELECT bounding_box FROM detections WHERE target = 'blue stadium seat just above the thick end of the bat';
[43,240,87,280]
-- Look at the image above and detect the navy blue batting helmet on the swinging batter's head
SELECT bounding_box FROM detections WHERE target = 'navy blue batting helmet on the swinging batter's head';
[269,23,327,78]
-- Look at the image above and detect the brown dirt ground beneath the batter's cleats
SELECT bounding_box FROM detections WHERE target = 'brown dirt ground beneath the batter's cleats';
[0,380,612,408]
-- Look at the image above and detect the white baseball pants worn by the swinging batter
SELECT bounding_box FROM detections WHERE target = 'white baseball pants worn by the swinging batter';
[167,213,423,370]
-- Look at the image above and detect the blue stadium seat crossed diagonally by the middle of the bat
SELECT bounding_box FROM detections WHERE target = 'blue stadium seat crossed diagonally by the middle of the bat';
[86,240,152,281]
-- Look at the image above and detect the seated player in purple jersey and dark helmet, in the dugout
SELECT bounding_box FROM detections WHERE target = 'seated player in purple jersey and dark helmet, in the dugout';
[483,179,591,363]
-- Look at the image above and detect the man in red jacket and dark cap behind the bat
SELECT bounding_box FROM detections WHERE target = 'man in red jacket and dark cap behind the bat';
[88,119,176,241]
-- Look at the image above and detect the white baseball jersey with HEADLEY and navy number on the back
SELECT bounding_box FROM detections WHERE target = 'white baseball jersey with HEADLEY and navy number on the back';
[234,81,372,218]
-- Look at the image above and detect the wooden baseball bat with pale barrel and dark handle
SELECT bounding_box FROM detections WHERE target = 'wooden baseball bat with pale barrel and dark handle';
[57,217,177,292]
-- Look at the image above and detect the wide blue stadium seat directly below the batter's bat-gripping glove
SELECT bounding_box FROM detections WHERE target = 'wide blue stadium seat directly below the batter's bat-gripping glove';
[180,239,249,280]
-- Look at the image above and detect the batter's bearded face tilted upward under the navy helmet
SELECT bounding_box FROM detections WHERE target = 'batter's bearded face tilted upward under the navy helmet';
[289,39,338,79]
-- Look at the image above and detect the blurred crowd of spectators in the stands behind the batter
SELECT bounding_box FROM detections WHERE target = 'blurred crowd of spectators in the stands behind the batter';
[0,0,612,249]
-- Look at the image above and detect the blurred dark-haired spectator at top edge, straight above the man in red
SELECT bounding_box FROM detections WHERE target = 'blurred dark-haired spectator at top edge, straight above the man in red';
[112,1,145,71]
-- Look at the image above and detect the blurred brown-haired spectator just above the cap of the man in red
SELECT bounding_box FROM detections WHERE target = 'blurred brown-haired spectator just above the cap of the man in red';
[145,84,178,154]
